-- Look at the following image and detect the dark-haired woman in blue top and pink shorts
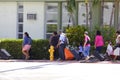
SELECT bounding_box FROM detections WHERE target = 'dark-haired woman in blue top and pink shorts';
[22,32,32,60]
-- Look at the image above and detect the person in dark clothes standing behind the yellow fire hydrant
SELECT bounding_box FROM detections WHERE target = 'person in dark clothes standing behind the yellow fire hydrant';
[50,31,59,59]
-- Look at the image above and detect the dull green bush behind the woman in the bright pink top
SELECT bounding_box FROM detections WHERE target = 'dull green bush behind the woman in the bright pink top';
[89,26,116,46]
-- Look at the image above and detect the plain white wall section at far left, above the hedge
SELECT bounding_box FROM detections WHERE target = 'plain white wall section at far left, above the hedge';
[0,2,17,38]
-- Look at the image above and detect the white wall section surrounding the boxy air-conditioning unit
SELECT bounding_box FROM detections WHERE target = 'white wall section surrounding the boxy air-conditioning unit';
[23,2,44,39]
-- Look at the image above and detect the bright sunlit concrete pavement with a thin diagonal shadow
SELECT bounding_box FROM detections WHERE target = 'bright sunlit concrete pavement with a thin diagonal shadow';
[0,60,120,80]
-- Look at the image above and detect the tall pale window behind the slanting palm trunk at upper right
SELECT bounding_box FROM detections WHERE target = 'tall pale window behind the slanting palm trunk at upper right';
[103,2,114,25]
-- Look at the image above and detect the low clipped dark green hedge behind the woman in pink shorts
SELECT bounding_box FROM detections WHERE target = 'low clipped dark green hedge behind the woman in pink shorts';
[0,39,49,59]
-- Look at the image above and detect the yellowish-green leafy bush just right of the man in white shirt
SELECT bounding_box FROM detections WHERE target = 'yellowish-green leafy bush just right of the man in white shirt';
[66,26,87,46]
